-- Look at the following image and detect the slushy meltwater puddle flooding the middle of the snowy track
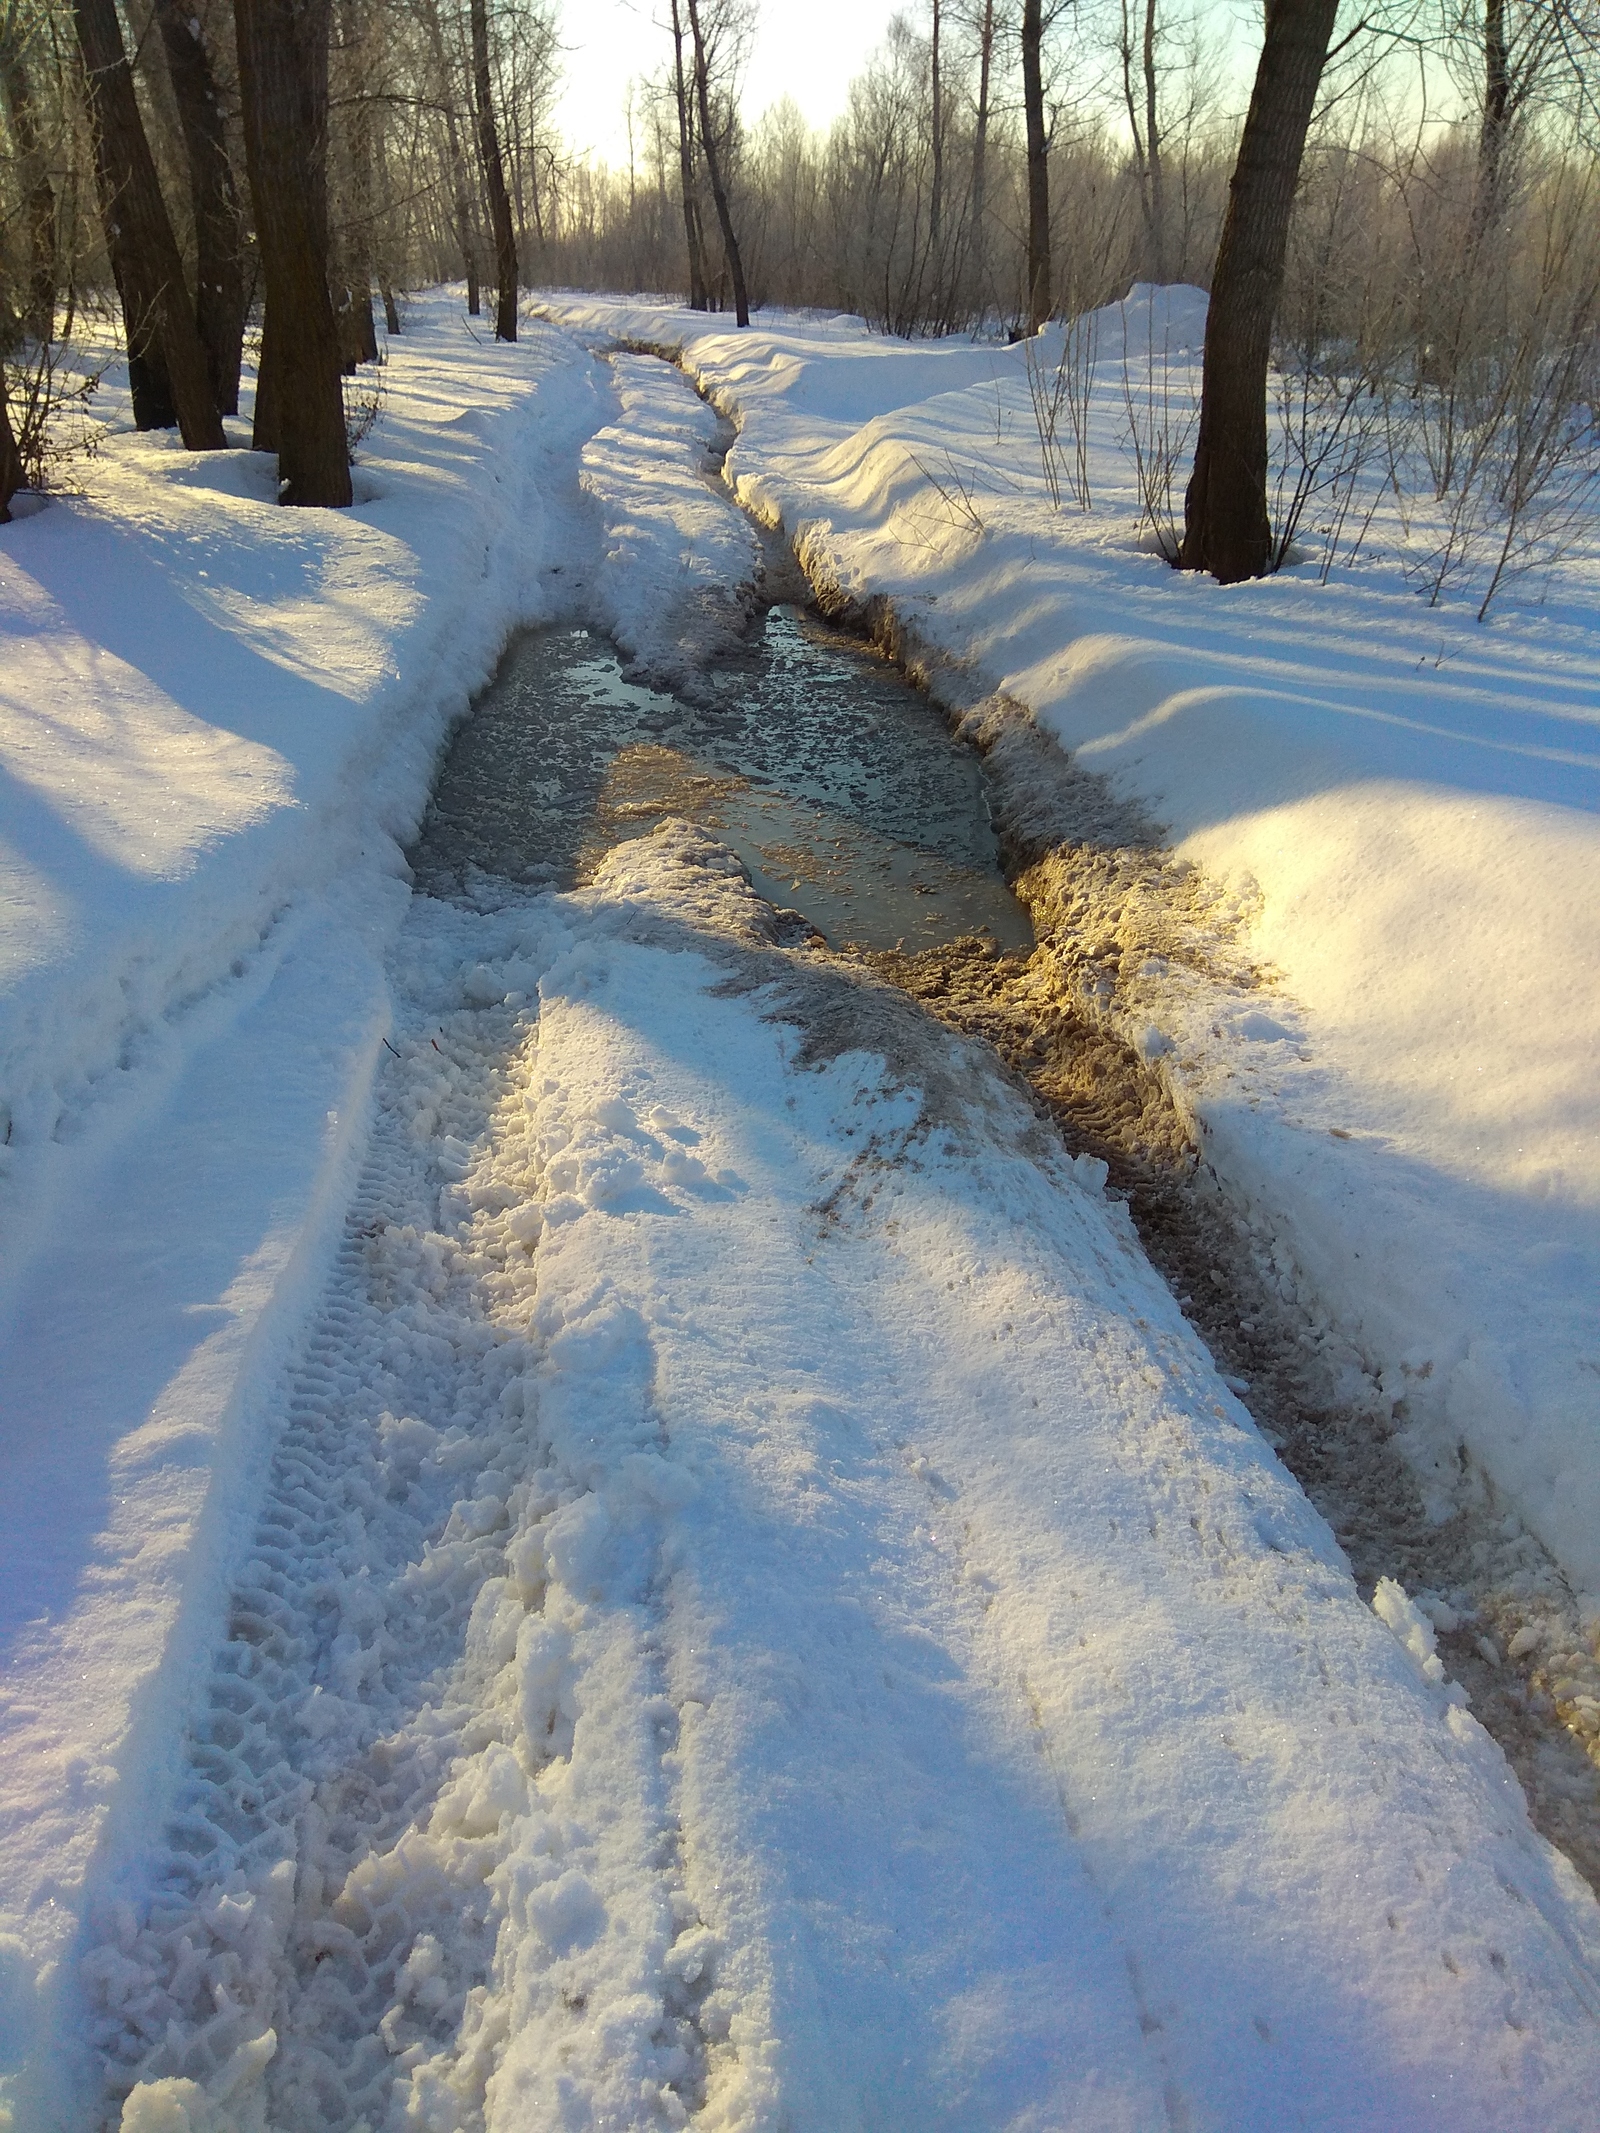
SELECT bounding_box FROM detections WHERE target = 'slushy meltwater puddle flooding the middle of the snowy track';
[410,606,1033,949]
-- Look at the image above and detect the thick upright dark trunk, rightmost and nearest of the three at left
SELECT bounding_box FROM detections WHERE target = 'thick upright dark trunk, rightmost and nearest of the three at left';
[235,0,350,506]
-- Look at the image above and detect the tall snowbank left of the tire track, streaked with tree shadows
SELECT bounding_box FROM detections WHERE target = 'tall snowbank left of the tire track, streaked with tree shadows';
[0,301,610,2116]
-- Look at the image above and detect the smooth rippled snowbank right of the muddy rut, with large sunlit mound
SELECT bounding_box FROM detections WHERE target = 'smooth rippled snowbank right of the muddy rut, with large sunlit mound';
[548,290,1600,1593]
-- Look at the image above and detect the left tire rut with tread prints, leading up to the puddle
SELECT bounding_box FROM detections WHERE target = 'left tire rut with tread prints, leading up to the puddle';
[83,900,708,2133]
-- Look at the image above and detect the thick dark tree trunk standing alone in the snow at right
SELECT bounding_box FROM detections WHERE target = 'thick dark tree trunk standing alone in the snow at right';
[1178,0,1338,584]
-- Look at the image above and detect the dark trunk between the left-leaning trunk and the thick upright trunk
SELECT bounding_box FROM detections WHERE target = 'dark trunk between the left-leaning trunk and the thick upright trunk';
[156,0,245,414]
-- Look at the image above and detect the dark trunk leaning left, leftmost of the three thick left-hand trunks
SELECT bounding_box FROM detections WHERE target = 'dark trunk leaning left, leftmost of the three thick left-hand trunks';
[73,0,228,452]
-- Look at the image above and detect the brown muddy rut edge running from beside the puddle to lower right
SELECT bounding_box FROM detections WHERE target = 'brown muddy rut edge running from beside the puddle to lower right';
[798,571,1600,1894]
